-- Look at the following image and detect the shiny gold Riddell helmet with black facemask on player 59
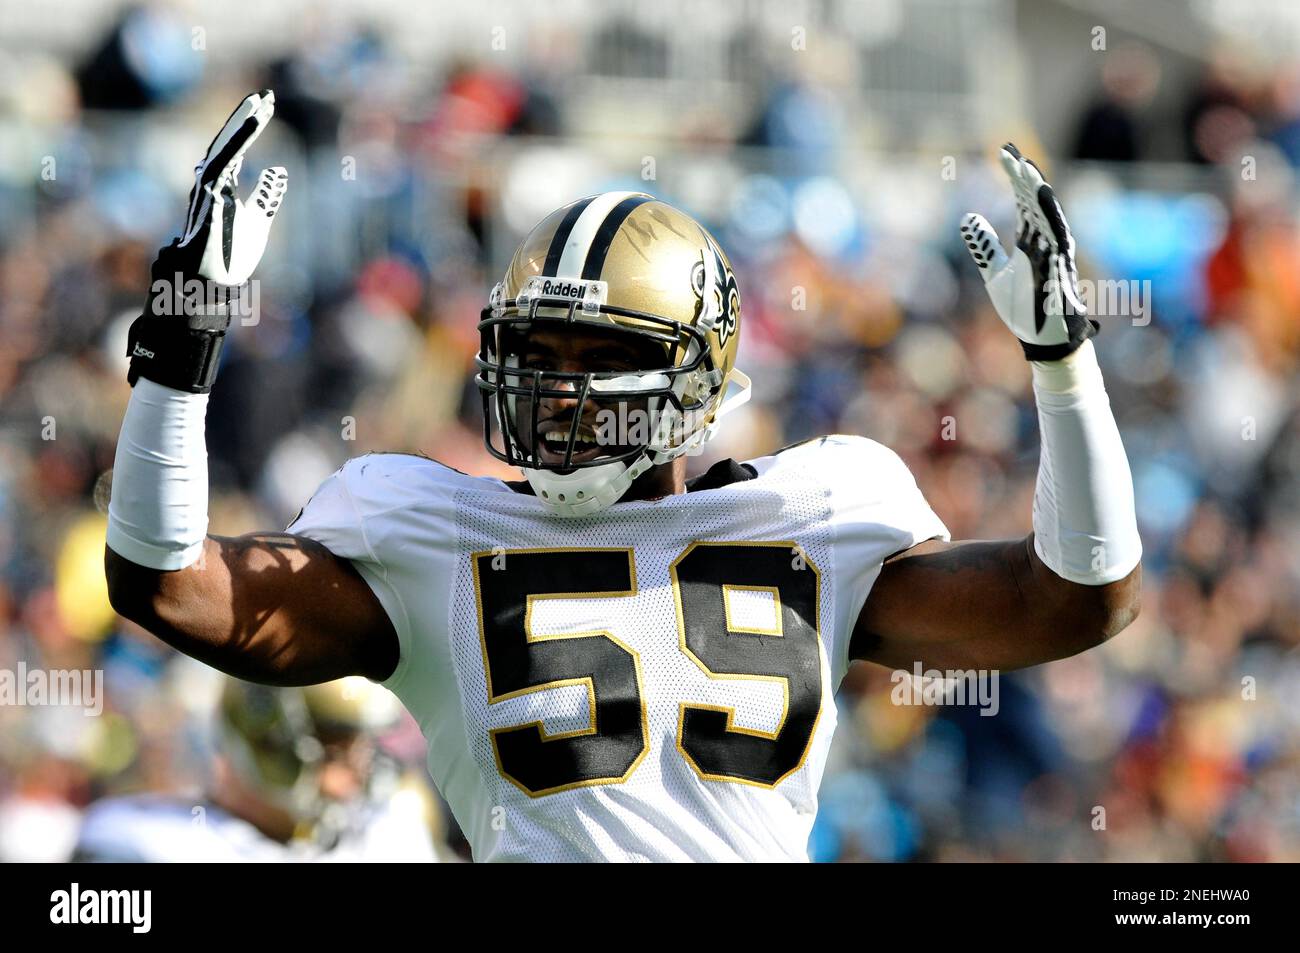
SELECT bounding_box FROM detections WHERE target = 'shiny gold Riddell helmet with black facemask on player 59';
[476,192,749,516]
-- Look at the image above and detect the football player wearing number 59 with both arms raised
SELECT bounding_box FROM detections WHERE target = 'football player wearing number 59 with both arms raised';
[105,92,1141,861]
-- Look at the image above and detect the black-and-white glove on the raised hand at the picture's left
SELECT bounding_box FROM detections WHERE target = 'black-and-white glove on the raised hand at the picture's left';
[176,90,289,286]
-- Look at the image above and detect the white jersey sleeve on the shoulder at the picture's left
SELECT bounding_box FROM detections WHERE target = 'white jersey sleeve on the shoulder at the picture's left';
[287,458,411,689]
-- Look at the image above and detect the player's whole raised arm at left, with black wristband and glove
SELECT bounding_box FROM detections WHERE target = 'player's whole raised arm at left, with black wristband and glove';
[104,90,398,685]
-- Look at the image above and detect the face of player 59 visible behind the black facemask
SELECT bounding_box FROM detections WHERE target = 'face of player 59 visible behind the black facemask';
[506,328,664,464]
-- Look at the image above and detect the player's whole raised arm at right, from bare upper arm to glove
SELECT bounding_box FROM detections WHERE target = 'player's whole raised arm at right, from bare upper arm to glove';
[850,144,1141,668]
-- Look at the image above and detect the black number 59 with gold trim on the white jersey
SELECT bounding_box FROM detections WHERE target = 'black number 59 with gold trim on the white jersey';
[471,541,822,797]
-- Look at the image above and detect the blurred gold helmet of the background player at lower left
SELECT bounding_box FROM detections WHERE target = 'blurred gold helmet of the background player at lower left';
[217,676,402,822]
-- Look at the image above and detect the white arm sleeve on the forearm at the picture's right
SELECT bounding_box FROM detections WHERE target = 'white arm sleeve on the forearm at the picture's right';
[1031,341,1141,585]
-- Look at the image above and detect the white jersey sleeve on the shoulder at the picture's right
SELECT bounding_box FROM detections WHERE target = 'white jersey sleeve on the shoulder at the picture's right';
[818,436,949,685]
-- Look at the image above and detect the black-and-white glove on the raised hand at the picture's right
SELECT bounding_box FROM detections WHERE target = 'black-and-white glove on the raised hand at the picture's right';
[962,143,1099,360]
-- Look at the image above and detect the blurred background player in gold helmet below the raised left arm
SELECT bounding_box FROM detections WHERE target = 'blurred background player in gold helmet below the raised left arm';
[73,676,438,863]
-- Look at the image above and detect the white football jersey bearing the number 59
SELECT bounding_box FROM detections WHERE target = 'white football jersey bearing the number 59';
[289,437,948,861]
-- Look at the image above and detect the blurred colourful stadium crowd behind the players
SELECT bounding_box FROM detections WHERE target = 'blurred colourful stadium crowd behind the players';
[0,0,1300,861]
